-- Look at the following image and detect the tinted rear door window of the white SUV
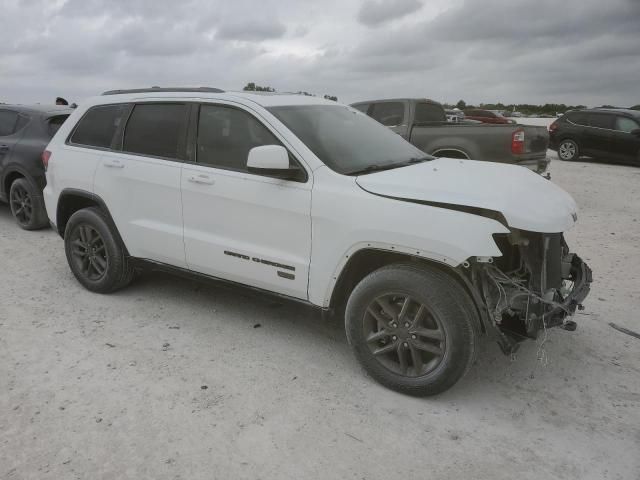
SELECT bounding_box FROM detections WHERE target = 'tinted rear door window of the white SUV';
[122,103,188,158]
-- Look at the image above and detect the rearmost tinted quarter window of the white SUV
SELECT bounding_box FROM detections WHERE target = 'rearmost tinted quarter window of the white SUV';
[69,104,129,148]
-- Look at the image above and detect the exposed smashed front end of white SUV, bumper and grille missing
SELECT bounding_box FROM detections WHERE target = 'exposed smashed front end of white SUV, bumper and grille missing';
[469,229,592,354]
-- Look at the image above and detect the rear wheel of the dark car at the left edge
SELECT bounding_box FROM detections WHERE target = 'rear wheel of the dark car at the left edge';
[9,178,49,230]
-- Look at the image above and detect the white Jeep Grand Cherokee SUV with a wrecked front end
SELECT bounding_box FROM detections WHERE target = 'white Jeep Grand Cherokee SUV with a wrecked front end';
[43,88,591,395]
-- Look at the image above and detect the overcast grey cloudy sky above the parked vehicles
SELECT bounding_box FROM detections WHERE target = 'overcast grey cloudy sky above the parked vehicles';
[0,0,640,106]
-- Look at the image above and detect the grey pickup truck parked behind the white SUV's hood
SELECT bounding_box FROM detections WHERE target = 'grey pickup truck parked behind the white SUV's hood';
[351,98,549,173]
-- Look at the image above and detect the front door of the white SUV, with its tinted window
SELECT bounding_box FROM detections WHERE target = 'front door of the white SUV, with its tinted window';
[181,104,311,299]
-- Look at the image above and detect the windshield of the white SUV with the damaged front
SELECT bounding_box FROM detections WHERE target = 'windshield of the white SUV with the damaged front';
[267,105,432,175]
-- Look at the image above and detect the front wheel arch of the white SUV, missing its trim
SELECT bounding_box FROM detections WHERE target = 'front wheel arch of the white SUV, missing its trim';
[328,247,488,333]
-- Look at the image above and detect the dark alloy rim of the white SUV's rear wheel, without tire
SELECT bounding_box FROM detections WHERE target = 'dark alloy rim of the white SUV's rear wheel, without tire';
[70,224,109,281]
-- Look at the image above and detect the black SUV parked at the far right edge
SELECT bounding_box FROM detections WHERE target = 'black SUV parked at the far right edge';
[549,108,640,165]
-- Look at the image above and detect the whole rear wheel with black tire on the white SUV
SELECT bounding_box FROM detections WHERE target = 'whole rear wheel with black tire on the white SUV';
[64,207,134,293]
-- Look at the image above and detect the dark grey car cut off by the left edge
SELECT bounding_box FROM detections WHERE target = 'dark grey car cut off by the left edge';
[0,104,72,230]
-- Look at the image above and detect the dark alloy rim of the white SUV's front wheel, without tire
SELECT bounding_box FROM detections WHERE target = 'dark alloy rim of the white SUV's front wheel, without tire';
[363,294,447,377]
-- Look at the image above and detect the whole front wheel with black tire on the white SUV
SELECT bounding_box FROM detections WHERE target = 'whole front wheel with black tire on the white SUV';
[345,264,478,396]
